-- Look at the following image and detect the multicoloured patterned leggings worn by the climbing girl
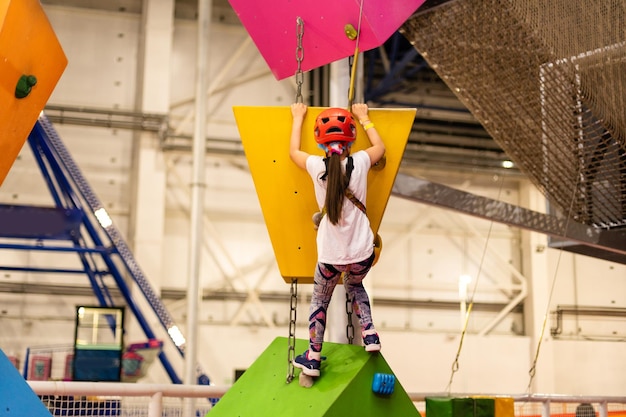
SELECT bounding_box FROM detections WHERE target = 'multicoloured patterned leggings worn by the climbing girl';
[309,249,374,352]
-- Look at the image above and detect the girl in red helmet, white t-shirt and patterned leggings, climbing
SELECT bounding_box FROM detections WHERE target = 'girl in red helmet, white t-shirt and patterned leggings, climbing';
[289,103,385,376]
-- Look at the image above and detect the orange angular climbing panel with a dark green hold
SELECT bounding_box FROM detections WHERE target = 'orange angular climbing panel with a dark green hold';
[0,0,67,185]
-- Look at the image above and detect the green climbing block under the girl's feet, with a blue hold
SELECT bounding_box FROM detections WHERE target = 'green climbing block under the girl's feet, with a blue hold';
[207,337,420,417]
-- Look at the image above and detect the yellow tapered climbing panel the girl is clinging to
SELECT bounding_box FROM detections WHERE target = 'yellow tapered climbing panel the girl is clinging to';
[233,106,415,283]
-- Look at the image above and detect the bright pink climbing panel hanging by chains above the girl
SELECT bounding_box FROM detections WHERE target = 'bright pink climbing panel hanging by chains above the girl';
[229,0,425,80]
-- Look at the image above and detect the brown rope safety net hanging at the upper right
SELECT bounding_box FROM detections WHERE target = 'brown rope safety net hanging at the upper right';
[401,0,626,228]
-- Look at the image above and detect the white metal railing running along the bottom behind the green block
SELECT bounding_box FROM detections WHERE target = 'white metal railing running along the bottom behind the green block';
[28,381,626,417]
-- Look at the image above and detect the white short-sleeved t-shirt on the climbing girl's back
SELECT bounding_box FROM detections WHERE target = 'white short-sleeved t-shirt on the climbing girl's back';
[306,151,374,265]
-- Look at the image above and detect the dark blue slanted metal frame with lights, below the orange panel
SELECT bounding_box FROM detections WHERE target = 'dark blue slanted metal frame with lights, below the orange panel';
[0,115,210,385]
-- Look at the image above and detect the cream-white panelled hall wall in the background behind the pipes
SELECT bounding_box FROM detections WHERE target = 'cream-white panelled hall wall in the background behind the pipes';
[0,7,626,395]
